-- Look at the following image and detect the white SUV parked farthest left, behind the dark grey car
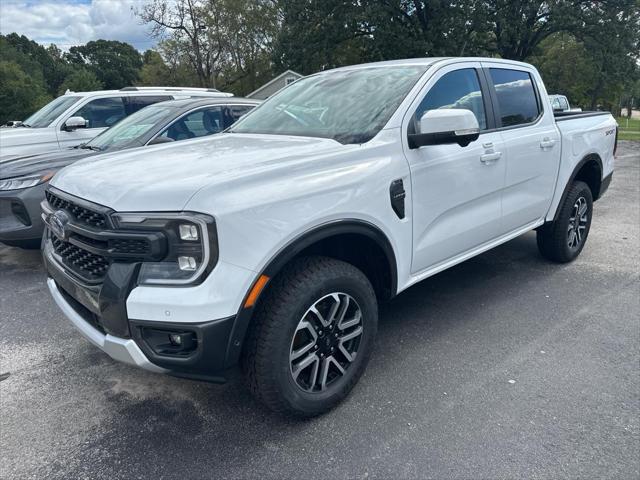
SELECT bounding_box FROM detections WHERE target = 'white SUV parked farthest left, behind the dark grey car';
[0,87,233,161]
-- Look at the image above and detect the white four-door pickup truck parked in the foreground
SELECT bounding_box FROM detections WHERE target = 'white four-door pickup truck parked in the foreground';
[42,58,617,416]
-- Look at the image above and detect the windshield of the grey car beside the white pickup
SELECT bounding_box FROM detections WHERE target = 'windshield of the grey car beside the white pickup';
[85,105,175,150]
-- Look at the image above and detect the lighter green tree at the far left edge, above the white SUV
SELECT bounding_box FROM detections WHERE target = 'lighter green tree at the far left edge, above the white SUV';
[0,60,51,124]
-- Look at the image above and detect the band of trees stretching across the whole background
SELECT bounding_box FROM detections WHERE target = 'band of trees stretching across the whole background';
[0,0,640,124]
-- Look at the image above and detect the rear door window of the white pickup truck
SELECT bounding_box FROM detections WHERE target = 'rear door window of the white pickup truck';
[490,68,540,127]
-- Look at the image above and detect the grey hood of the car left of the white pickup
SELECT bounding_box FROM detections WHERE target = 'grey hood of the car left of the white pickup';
[0,148,97,179]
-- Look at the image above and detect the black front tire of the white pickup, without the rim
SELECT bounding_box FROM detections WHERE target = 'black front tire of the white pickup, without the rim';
[242,257,378,417]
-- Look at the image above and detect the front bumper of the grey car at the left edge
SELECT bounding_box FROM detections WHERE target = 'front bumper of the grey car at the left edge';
[0,183,48,246]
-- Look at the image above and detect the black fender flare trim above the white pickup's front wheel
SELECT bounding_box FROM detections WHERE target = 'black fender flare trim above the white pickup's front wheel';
[225,219,398,368]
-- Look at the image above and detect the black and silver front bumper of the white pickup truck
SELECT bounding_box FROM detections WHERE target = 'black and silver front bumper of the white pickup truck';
[43,231,235,383]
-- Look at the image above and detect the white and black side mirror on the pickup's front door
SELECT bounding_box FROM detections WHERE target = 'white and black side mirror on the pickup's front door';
[409,108,480,149]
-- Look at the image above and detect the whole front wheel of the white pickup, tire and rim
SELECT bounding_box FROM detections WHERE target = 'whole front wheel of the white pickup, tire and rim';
[243,257,378,417]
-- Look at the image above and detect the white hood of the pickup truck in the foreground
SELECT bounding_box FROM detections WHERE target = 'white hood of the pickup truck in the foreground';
[51,133,349,211]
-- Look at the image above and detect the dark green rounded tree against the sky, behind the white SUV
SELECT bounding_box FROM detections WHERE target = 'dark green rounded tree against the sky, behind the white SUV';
[65,40,142,89]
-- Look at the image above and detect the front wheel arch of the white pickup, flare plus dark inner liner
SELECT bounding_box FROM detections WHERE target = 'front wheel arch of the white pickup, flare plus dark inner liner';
[225,219,398,367]
